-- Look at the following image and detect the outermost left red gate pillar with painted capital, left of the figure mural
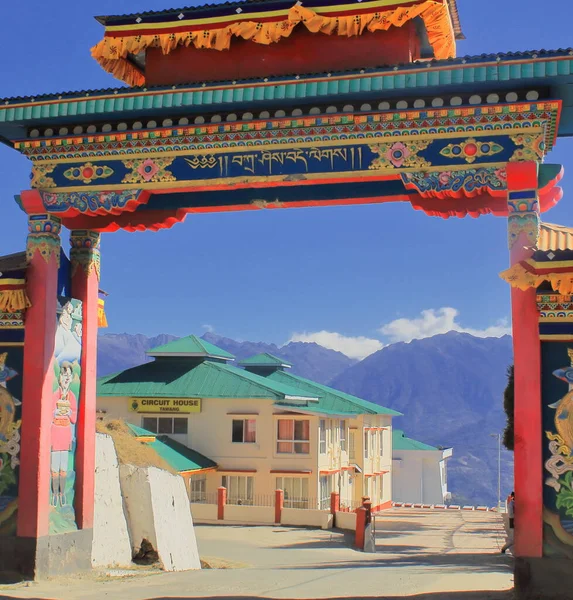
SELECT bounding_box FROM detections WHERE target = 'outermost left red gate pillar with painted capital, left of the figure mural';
[17,214,61,538]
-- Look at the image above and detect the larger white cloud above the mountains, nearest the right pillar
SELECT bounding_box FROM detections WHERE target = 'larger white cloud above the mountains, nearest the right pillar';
[379,307,511,344]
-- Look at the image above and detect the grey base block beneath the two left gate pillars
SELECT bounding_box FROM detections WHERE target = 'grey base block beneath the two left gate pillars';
[0,529,93,581]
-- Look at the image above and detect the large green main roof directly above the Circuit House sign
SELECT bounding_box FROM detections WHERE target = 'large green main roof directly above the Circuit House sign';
[97,358,316,401]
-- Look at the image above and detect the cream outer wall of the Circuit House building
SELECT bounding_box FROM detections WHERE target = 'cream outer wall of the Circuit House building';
[98,397,392,508]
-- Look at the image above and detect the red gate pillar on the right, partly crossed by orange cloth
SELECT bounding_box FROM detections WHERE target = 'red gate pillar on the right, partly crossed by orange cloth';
[507,162,543,558]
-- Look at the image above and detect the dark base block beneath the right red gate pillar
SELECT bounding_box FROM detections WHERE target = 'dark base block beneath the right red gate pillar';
[514,557,573,600]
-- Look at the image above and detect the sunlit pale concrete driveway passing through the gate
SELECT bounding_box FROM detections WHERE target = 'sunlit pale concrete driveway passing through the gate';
[0,509,512,600]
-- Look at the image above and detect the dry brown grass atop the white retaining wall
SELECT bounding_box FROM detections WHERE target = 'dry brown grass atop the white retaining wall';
[96,419,178,475]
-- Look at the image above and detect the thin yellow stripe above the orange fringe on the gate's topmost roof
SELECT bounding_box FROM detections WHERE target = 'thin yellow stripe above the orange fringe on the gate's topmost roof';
[105,0,413,33]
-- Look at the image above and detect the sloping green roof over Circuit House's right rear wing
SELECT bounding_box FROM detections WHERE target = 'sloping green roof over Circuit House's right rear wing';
[266,371,402,417]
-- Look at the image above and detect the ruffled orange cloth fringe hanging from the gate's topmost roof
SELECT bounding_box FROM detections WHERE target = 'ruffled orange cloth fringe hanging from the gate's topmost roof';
[91,0,456,86]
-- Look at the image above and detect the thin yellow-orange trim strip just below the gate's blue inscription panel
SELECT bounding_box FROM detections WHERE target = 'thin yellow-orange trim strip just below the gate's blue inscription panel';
[33,163,507,193]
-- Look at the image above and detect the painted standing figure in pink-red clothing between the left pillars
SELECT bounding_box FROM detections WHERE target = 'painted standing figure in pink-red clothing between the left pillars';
[51,361,78,506]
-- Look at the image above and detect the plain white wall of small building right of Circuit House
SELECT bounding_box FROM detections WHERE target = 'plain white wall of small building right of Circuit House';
[392,450,447,504]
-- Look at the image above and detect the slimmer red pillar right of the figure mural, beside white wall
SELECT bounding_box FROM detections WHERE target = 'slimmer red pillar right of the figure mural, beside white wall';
[70,230,100,529]
